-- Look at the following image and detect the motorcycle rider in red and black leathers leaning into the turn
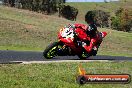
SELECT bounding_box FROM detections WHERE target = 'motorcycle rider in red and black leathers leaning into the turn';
[74,13,102,56]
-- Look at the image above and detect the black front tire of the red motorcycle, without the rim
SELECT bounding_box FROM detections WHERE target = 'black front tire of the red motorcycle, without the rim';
[43,42,59,59]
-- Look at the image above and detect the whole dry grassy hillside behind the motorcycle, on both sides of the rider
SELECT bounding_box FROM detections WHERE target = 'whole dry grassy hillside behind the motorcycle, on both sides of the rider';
[0,6,132,56]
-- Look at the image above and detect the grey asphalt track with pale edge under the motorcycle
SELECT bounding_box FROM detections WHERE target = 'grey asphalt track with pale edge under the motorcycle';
[0,50,132,63]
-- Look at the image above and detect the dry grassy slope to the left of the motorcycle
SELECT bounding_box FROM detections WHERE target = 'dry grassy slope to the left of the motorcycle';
[0,6,72,49]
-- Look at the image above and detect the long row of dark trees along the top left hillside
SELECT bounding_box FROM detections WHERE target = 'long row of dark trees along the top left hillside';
[4,0,65,14]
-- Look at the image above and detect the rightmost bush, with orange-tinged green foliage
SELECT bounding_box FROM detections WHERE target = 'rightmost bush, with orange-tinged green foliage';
[111,8,132,32]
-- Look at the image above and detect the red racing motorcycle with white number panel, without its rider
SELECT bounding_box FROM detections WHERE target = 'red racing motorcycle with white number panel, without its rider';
[43,26,107,59]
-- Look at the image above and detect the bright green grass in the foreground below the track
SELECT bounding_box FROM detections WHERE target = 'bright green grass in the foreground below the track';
[0,62,132,88]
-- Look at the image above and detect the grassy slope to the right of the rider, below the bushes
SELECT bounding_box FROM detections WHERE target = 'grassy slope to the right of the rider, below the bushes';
[98,29,132,56]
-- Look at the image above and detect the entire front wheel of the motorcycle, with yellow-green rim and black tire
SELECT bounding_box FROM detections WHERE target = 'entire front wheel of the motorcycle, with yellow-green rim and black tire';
[43,42,59,59]
